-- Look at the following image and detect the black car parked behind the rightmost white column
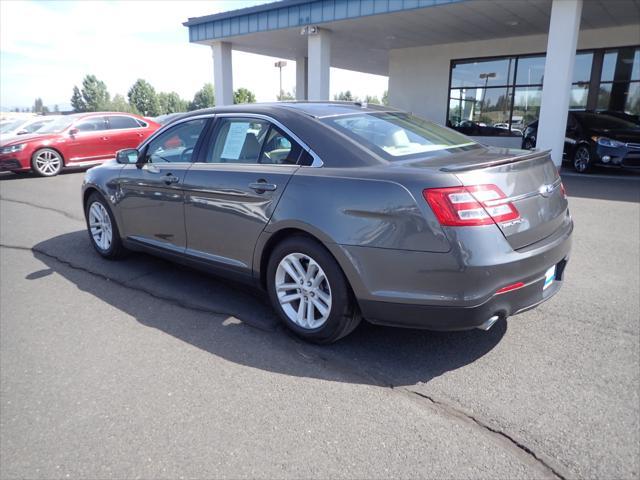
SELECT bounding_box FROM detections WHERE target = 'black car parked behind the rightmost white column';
[522,111,640,173]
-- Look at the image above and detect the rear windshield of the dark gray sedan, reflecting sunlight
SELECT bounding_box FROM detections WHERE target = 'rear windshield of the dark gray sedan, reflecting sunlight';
[323,112,480,161]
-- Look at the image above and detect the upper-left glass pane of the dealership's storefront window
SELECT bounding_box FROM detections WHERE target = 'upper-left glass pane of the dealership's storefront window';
[451,58,515,88]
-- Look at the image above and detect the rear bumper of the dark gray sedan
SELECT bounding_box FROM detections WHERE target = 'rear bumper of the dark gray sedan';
[341,213,573,330]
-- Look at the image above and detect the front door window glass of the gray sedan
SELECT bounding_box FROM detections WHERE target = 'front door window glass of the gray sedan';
[146,118,206,163]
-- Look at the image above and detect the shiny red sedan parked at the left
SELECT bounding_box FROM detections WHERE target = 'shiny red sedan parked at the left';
[0,112,160,177]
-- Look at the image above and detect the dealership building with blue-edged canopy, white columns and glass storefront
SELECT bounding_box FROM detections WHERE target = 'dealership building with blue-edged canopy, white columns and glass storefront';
[185,0,640,165]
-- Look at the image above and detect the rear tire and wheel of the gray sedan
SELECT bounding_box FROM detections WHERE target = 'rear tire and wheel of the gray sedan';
[267,236,360,343]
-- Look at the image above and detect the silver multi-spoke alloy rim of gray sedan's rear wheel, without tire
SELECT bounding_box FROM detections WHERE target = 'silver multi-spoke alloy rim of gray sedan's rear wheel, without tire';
[275,253,331,330]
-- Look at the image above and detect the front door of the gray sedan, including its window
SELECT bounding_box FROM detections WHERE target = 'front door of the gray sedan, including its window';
[118,118,208,252]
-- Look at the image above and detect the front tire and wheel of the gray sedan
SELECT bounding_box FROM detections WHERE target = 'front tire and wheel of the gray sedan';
[84,192,126,260]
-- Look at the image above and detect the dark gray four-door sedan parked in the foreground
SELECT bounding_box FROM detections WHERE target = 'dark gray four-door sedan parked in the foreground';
[82,103,573,343]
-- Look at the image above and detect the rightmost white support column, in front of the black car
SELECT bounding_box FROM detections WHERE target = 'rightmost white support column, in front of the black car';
[536,0,583,167]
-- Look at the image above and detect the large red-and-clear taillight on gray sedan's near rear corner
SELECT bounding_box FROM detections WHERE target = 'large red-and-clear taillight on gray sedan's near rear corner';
[422,185,520,227]
